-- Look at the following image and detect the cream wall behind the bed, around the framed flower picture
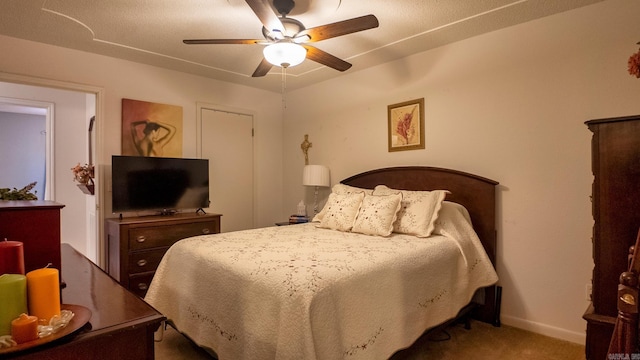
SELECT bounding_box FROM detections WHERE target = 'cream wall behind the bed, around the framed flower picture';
[284,0,640,342]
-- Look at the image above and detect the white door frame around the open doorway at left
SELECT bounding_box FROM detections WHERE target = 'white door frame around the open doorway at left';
[0,72,108,269]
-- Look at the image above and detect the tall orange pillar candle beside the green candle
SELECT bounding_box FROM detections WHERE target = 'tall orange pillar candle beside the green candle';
[27,268,60,324]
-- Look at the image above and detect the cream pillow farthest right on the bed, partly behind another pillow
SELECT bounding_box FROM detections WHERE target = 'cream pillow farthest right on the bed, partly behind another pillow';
[373,185,450,237]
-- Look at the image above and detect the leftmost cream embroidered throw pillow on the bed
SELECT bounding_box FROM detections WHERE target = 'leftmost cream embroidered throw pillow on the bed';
[320,192,364,231]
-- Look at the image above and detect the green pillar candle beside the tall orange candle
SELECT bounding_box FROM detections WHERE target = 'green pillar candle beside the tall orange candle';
[0,274,27,336]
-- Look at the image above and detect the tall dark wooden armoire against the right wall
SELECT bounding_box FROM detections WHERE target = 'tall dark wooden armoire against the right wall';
[583,115,640,360]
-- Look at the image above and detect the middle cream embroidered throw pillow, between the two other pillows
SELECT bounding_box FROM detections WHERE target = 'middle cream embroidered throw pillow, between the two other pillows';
[351,193,402,236]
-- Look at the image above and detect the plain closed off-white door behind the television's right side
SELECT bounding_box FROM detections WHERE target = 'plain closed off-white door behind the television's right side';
[199,107,254,232]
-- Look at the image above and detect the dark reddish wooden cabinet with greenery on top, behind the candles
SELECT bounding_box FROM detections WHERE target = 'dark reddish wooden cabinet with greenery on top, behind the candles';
[0,200,64,272]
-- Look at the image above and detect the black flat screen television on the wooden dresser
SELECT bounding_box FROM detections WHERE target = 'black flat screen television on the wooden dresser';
[111,155,209,213]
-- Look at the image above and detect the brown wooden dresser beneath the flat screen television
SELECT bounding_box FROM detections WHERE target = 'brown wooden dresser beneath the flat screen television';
[106,213,221,297]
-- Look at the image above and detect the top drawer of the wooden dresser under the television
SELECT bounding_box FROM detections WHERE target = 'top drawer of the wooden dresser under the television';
[129,221,217,250]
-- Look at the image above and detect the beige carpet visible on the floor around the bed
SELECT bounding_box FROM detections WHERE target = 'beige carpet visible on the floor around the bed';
[155,321,585,360]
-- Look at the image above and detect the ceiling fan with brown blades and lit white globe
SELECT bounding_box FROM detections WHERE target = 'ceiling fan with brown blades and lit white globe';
[183,0,378,77]
